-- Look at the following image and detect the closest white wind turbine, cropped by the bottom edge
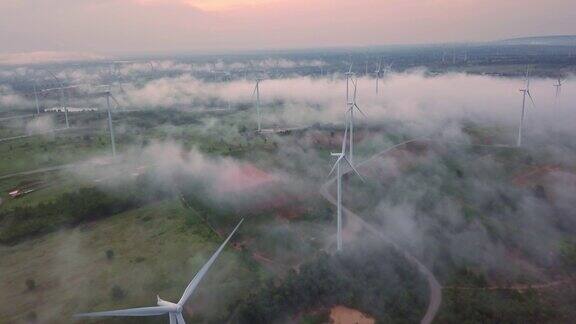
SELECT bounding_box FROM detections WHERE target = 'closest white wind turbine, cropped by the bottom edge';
[74,219,244,324]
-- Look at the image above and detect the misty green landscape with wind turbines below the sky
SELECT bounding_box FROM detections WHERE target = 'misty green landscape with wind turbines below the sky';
[0,2,576,324]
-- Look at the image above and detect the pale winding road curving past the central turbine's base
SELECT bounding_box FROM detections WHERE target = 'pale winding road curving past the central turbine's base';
[320,139,442,324]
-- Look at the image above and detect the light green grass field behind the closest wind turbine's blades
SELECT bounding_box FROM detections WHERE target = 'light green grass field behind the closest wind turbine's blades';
[0,200,259,323]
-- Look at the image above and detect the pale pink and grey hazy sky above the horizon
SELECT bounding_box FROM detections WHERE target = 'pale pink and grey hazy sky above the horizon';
[0,0,576,56]
